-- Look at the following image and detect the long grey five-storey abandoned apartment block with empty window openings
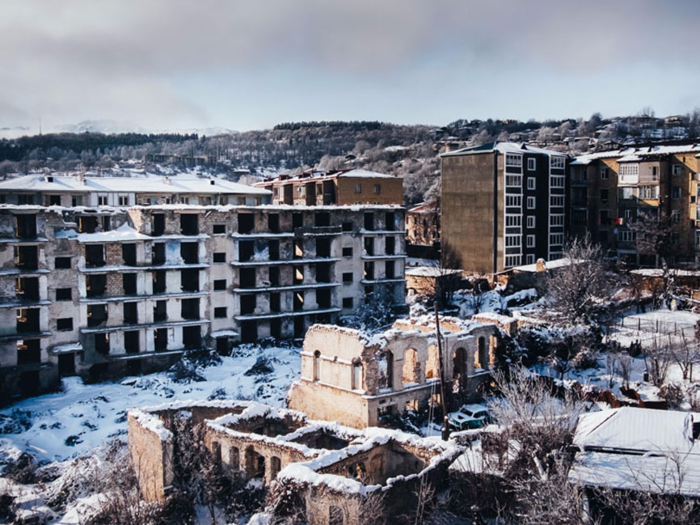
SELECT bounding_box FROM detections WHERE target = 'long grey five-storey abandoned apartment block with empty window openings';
[0,204,405,401]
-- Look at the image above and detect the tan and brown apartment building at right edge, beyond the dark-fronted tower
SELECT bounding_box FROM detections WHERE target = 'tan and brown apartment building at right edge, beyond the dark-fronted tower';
[571,144,700,265]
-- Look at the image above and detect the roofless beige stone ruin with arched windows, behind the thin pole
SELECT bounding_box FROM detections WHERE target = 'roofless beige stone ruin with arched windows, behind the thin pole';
[288,316,502,428]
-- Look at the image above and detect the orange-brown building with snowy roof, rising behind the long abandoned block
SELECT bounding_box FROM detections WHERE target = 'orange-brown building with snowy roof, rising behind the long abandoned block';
[256,169,403,206]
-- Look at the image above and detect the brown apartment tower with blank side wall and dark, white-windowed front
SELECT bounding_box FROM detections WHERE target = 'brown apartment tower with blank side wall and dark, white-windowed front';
[441,142,569,274]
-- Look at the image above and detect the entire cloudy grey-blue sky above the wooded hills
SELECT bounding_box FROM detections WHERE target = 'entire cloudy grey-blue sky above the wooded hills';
[0,0,700,130]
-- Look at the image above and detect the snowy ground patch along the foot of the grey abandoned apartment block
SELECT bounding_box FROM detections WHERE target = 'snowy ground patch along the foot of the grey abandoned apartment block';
[0,347,301,461]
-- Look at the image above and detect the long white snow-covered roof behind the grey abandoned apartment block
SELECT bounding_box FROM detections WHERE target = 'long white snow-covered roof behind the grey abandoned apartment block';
[0,173,270,195]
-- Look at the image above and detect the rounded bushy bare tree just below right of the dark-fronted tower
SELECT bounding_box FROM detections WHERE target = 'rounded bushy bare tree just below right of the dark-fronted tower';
[547,236,611,325]
